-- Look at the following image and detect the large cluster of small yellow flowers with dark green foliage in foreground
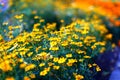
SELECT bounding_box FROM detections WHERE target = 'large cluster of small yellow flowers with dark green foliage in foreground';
[0,15,110,80]
